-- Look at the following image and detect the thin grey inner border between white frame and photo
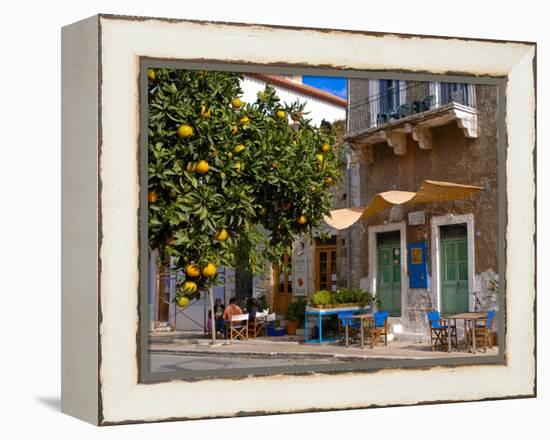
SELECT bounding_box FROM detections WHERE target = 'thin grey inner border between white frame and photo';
[136,56,508,384]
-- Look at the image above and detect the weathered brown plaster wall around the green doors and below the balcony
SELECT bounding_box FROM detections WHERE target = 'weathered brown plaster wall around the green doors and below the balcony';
[338,80,498,332]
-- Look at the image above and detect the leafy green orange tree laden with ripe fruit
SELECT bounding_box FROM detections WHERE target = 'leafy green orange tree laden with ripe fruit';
[148,69,341,303]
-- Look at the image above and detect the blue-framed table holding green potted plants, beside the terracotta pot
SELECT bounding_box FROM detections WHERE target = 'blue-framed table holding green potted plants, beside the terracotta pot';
[305,306,370,344]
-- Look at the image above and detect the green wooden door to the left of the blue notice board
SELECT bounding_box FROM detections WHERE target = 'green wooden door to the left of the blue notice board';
[376,245,401,316]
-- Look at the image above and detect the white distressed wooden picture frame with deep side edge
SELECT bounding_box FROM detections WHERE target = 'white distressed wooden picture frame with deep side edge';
[62,15,536,425]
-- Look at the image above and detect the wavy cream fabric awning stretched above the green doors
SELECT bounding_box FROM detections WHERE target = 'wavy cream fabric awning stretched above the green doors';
[324,180,483,229]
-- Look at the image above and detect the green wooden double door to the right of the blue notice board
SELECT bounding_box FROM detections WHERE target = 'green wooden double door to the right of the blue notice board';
[441,238,468,313]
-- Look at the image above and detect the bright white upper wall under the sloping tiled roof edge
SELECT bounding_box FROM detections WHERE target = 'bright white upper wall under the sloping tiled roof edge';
[241,76,346,126]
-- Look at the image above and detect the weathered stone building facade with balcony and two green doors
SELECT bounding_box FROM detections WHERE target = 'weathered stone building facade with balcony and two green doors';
[337,79,498,334]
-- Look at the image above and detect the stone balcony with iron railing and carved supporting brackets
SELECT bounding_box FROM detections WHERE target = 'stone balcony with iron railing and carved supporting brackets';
[345,82,477,155]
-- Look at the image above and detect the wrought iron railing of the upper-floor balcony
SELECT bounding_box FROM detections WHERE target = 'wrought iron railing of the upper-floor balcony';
[347,82,475,135]
